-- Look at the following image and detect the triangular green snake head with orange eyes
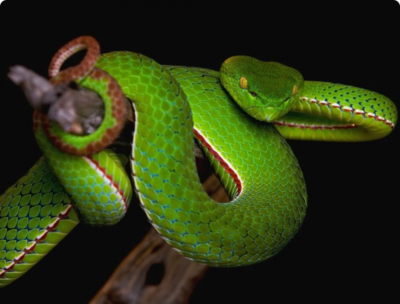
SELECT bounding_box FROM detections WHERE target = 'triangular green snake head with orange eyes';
[221,56,304,122]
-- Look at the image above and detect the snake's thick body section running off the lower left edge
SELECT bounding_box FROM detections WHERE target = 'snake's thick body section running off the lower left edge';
[0,158,79,287]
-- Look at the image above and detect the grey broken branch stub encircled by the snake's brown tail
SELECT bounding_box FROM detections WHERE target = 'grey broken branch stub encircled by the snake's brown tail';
[8,66,104,135]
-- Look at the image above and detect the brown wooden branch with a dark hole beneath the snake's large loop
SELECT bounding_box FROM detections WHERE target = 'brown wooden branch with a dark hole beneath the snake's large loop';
[90,175,228,304]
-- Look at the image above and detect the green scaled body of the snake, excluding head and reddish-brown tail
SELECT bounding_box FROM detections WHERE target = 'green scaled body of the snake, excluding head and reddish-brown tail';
[0,48,397,287]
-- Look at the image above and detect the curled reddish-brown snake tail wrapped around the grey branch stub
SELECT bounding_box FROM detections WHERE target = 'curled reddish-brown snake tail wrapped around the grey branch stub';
[40,36,128,155]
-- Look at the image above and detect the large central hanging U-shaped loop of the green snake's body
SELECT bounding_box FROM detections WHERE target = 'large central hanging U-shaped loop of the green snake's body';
[98,52,307,266]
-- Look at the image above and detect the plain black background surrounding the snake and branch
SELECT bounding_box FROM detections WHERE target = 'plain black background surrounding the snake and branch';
[0,1,400,303]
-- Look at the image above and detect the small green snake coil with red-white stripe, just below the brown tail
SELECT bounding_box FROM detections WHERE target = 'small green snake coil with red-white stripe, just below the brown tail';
[35,123,132,226]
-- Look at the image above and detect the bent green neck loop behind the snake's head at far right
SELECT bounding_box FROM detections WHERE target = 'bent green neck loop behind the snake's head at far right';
[274,81,397,141]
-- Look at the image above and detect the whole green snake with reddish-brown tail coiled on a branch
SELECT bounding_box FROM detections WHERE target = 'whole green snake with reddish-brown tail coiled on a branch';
[0,37,397,287]
